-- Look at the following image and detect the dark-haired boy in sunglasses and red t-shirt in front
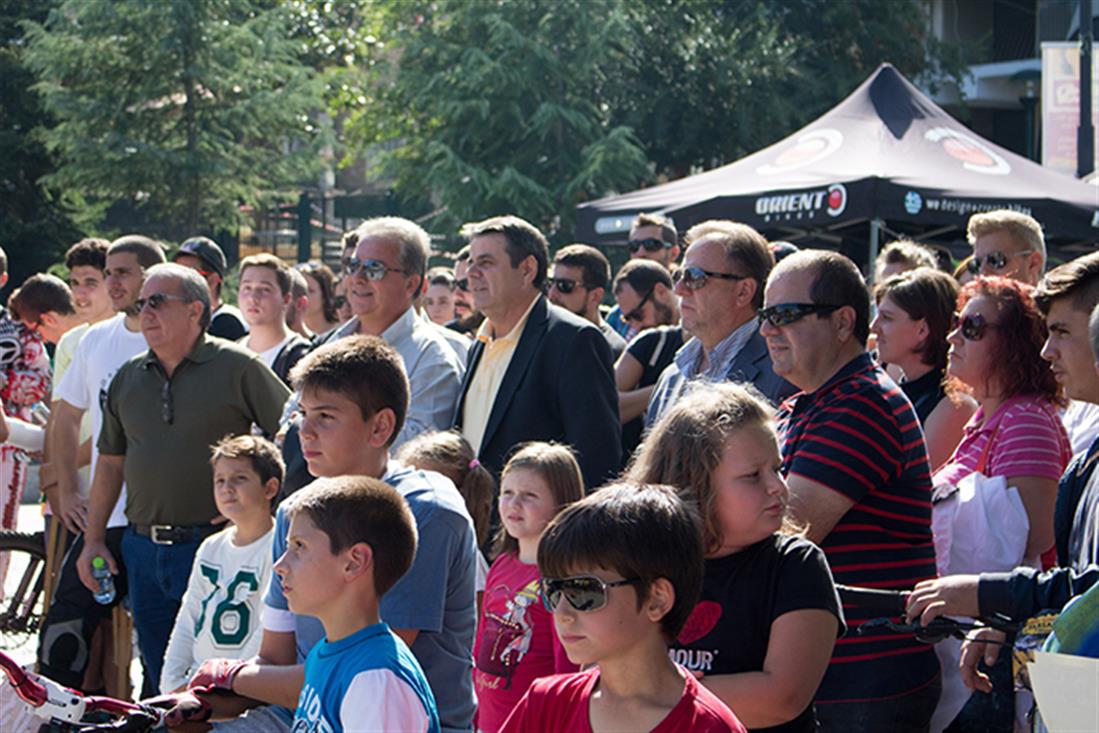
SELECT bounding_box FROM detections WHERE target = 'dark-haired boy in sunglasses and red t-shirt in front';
[501,484,744,733]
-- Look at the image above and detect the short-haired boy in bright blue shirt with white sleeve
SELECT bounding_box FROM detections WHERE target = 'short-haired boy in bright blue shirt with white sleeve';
[274,476,439,733]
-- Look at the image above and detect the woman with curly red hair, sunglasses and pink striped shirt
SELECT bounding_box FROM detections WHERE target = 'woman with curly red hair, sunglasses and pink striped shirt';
[932,277,1072,730]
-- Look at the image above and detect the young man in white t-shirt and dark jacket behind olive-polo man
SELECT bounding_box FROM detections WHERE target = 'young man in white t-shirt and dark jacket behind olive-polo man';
[236,253,309,385]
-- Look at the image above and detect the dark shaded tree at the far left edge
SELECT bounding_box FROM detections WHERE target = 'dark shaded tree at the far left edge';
[0,0,80,292]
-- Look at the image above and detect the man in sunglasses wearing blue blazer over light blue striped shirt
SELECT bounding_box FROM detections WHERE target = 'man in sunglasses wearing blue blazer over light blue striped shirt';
[645,221,797,425]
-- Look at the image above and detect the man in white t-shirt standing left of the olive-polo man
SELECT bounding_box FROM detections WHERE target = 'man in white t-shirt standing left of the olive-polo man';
[38,235,165,689]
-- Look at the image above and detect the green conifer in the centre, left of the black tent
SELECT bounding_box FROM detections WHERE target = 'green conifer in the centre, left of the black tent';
[351,0,648,234]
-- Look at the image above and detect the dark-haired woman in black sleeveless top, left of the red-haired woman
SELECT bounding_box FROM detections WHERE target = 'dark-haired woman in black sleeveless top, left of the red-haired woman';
[870,267,977,469]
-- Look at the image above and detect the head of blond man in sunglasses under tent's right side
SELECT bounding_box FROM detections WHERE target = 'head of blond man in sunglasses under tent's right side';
[966,209,1045,285]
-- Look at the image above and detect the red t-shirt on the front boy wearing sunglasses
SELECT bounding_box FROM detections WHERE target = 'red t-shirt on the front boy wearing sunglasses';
[501,667,745,733]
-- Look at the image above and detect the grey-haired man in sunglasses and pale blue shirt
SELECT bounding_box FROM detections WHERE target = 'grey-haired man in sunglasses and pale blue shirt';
[309,216,465,447]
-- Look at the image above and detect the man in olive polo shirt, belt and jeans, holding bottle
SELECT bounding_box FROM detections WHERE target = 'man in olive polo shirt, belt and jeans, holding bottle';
[77,264,290,690]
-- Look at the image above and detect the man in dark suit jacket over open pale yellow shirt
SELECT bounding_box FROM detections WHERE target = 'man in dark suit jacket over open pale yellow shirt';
[454,216,622,490]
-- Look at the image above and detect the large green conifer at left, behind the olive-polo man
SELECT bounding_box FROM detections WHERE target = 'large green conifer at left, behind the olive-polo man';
[27,0,322,236]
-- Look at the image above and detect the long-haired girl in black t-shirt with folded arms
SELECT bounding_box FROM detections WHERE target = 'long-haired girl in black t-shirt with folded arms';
[630,384,844,733]
